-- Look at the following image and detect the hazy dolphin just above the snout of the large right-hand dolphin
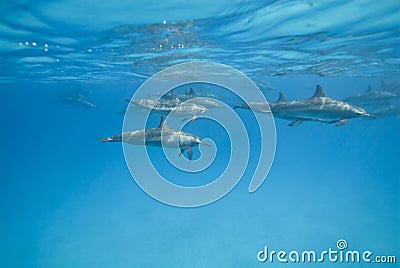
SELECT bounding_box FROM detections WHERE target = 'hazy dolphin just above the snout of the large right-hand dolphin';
[343,86,397,105]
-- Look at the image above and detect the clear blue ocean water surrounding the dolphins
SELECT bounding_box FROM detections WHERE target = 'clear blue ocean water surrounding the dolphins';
[0,0,400,268]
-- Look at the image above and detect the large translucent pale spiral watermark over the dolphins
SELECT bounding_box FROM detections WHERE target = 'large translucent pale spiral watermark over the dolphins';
[123,62,276,207]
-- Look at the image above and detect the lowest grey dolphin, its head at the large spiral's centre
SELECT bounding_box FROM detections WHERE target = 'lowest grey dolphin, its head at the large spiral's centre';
[99,116,201,160]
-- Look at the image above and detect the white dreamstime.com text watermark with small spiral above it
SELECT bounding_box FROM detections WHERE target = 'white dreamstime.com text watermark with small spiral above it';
[257,239,396,264]
